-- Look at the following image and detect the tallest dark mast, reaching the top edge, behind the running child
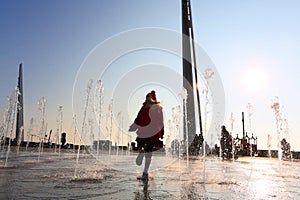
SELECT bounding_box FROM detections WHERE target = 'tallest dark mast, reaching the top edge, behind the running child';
[182,0,203,148]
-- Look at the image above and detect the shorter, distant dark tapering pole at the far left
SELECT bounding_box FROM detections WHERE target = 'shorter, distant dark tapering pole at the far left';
[15,63,24,141]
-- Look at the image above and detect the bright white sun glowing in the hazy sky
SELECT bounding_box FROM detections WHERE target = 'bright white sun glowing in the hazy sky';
[242,67,267,92]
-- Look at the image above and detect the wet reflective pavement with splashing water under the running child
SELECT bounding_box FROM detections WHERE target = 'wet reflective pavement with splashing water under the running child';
[0,151,300,200]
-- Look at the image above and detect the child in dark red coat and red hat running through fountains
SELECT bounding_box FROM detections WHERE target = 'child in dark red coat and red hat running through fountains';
[129,90,164,181]
